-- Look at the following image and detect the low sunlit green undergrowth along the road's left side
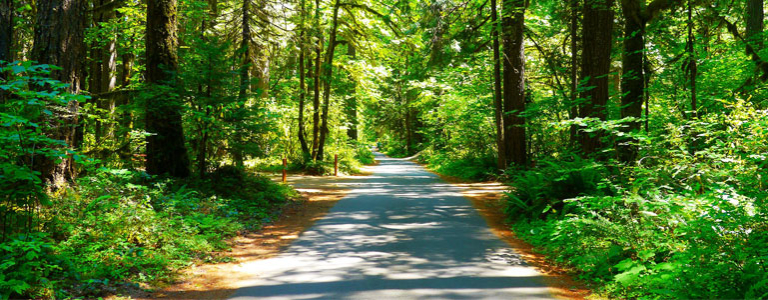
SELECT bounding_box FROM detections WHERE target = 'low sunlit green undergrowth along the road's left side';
[0,167,297,299]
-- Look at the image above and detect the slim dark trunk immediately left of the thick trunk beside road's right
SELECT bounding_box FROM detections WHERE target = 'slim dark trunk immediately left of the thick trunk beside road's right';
[491,0,507,170]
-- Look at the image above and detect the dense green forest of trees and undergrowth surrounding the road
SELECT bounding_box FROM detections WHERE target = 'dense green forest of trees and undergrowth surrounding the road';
[0,0,768,299]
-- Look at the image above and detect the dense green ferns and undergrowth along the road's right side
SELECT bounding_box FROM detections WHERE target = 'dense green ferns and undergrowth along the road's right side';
[506,101,768,299]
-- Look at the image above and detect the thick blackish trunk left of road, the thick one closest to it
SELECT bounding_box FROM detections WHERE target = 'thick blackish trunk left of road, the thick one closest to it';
[146,0,189,177]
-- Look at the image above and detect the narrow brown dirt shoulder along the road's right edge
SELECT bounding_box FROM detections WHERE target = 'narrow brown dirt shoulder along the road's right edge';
[411,159,591,299]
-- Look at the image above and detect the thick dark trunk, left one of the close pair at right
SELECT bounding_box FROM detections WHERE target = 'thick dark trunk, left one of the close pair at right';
[579,0,613,154]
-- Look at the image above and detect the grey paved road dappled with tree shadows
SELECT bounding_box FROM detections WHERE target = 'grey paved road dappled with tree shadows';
[233,154,552,300]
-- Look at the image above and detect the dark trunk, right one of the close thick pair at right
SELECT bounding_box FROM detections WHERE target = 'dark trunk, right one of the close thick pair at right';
[618,0,645,163]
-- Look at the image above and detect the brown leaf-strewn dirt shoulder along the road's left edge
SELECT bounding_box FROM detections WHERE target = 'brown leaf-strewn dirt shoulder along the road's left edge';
[142,174,360,299]
